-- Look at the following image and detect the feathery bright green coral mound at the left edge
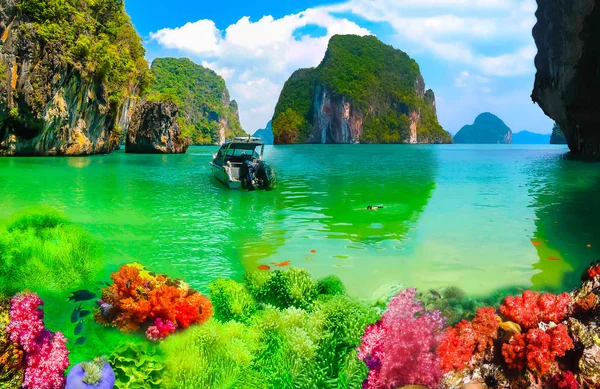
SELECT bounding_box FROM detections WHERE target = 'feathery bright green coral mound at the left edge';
[0,210,102,295]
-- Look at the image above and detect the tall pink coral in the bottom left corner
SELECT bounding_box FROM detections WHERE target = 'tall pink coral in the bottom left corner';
[6,293,69,389]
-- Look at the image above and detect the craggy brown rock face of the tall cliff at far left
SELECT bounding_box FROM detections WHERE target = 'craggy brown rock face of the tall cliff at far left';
[0,0,149,155]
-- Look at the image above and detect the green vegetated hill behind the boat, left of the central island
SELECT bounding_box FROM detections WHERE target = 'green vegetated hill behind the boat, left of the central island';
[148,58,246,145]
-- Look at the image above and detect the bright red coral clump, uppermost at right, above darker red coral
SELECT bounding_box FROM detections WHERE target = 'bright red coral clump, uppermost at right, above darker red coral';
[500,290,572,329]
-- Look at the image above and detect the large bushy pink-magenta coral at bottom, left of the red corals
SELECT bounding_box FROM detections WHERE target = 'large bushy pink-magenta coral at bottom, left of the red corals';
[358,289,445,389]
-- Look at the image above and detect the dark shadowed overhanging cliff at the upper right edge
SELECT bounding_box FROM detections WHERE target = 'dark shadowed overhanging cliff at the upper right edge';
[532,0,600,158]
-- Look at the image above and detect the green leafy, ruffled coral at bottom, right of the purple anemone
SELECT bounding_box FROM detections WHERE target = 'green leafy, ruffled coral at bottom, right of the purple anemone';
[109,342,165,389]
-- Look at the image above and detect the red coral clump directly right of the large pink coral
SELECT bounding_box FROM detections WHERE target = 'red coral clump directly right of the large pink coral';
[438,307,499,373]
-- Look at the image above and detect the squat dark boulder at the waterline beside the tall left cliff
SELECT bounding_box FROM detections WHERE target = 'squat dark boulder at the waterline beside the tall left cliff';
[125,101,189,154]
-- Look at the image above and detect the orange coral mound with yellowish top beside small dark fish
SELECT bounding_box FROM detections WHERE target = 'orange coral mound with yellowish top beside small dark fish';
[95,264,213,340]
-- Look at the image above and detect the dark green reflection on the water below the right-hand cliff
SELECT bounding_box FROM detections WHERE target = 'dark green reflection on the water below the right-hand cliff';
[531,156,600,290]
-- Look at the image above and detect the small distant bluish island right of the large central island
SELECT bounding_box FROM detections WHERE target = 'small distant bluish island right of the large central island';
[454,112,512,144]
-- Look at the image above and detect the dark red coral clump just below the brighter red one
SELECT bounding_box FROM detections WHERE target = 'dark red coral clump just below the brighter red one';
[502,324,574,375]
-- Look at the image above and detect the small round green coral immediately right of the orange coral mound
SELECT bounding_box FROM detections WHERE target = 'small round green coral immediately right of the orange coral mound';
[209,279,256,323]
